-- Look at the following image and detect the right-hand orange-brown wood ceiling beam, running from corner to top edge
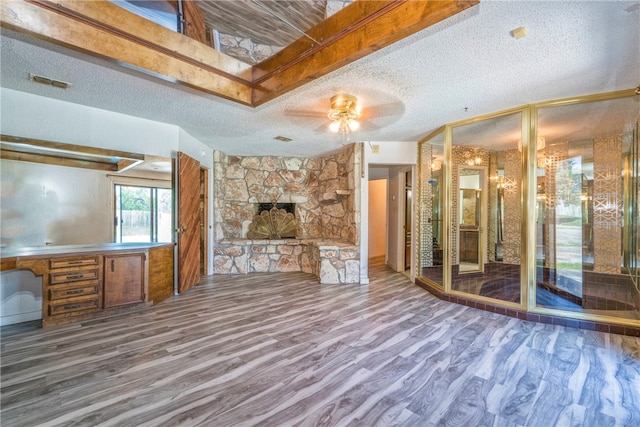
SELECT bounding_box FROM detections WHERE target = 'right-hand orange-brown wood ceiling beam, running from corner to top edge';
[252,0,480,106]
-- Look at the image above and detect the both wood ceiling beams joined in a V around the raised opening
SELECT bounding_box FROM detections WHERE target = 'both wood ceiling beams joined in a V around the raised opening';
[0,0,479,106]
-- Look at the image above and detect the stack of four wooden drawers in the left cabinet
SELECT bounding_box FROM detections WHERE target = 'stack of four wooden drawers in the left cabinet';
[43,255,102,323]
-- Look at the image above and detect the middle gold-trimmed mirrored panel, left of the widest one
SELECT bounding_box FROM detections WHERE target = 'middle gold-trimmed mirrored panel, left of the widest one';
[450,112,522,303]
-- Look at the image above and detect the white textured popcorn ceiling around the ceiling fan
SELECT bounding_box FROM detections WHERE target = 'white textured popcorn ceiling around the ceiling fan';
[0,0,640,157]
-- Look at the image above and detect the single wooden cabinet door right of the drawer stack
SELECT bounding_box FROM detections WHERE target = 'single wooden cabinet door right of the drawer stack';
[103,254,145,308]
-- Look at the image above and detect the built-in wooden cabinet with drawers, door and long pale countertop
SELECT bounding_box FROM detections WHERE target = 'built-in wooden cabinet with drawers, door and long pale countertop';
[0,243,174,327]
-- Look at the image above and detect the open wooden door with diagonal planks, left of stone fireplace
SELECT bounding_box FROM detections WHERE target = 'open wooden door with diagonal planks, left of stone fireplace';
[176,152,200,293]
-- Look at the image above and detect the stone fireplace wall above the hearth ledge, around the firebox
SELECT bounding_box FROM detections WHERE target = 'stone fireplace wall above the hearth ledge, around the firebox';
[214,146,358,243]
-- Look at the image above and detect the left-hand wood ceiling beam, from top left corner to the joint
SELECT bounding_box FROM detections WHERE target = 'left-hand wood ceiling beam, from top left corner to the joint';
[0,0,251,105]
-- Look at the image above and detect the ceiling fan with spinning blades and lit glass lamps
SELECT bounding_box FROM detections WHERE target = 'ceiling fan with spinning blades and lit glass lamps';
[285,93,404,143]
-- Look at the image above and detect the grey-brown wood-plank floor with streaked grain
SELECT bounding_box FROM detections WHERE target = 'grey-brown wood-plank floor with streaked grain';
[0,264,640,427]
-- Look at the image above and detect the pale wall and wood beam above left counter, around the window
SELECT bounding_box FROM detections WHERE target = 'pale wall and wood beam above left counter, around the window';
[0,135,172,247]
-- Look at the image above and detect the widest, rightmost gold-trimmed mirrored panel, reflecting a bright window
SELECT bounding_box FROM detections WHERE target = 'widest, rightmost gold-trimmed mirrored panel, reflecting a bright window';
[536,96,640,319]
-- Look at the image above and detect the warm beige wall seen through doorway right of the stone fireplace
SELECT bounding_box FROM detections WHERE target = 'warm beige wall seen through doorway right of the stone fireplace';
[368,179,387,258]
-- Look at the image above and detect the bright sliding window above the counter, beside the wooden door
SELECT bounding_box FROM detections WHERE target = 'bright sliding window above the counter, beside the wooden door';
[114,184,172,243]
